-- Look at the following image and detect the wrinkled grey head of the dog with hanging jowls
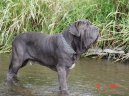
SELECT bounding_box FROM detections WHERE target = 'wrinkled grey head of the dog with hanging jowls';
[69,20,99,51]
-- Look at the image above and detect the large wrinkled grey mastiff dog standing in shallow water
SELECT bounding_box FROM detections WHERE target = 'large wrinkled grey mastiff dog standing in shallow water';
[7,20,99,94]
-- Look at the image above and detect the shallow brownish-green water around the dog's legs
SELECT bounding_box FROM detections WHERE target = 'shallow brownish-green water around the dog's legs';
[0,55,129,96]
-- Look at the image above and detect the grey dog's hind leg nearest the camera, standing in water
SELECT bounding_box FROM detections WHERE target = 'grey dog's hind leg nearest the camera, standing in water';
[7,42,25,84]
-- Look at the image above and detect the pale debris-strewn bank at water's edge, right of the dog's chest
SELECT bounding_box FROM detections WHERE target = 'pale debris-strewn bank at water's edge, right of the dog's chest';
[84,48,129,62]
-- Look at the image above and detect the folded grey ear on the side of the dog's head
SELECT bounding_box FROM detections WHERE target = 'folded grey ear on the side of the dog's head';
[69,22,80,37]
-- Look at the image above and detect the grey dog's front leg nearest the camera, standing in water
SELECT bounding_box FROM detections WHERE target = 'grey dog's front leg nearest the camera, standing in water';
[57,65,68,95]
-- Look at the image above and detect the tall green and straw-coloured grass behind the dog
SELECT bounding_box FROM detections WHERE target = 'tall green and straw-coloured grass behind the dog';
[0,0,129,53]
